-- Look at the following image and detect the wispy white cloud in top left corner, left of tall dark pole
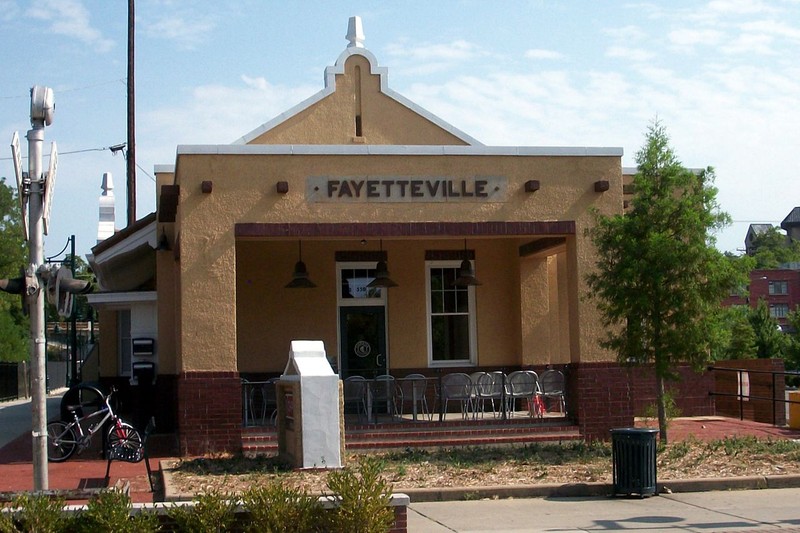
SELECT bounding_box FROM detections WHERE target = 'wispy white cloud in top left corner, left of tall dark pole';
[26,0,114,52]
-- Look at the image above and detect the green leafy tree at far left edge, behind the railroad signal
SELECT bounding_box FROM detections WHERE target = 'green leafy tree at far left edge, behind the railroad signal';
[0,178,29,361]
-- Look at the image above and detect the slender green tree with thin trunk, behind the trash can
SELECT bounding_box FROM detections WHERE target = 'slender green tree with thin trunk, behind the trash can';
[587,121,736,443]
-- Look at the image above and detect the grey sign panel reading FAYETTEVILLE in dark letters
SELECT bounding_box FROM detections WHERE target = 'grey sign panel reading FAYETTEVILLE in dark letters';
[306,176,507,202]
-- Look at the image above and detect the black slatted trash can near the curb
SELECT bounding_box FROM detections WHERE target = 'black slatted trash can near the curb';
[611,428,658,497]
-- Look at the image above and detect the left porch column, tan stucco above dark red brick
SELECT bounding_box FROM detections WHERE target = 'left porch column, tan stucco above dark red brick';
[177,229,242,455]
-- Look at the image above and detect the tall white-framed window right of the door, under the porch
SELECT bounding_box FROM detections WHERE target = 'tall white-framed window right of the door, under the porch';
[425,261,477,367]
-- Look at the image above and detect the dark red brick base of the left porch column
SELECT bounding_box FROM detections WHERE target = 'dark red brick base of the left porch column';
[177,372,242,456]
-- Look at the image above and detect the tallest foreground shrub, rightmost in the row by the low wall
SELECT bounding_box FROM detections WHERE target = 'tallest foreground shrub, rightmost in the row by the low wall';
[325,457,394,533]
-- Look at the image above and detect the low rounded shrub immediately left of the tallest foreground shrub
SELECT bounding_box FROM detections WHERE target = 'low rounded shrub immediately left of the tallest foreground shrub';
[242,481,323,533]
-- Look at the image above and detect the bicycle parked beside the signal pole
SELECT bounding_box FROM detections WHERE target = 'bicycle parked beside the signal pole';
[47,389,144,463]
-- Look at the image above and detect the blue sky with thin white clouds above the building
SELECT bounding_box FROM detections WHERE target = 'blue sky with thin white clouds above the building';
[0,0,800,255]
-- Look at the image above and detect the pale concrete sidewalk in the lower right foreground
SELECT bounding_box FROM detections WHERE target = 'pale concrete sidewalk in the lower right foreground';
[408,488,800,533]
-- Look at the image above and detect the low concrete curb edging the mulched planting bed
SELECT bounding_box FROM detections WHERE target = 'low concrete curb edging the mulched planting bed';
[160,459,800,503]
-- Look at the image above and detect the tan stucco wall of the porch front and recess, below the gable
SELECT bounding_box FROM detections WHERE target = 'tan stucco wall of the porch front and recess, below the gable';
[172,154,621,371]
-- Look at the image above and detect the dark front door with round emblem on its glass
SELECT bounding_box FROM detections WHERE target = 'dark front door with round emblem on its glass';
[339,306,388,379]
